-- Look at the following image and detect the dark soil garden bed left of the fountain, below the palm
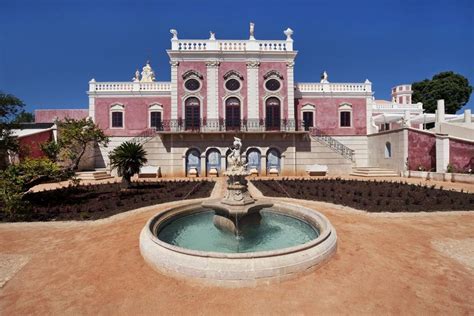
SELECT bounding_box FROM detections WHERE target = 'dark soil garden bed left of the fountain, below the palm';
[0,180,214,222]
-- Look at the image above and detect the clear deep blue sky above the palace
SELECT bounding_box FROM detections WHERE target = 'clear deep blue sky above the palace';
[0,0,474,111]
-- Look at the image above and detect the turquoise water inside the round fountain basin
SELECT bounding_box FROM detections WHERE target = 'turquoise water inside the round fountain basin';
[158,210,319,253]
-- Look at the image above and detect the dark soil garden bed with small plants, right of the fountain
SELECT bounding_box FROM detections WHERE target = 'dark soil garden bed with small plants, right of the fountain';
[252,179,474,212]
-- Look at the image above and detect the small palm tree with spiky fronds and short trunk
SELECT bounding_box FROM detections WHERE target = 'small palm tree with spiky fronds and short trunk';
[109,142,148,188]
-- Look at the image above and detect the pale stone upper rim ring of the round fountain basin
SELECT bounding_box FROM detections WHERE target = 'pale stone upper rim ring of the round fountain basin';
[144,199,335,259]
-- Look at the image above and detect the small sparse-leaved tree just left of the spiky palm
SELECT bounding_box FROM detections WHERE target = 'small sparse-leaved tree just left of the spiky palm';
[57,118,109,170]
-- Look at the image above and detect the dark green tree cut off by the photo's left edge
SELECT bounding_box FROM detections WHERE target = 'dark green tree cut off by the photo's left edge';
[0,91,24,170]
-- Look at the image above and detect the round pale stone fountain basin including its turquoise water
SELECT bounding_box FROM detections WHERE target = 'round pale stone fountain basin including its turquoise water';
[140,203,337,286]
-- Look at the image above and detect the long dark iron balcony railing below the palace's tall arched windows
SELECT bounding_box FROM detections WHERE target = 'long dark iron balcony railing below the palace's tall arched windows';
[155,119,296,133]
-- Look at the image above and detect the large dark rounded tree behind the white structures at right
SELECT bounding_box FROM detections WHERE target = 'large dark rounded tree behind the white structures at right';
[411,71,472,114]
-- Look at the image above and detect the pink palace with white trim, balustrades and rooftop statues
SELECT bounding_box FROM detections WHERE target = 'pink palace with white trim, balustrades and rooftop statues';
[36,24,474,176]
